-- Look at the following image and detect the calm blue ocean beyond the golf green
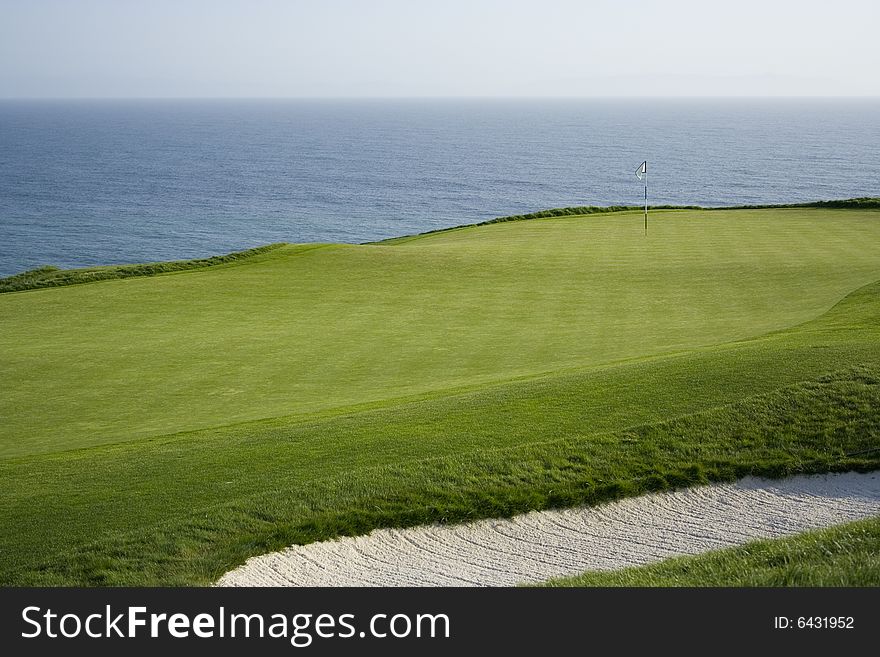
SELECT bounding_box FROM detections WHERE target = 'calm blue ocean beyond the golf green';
[0,99,880,276]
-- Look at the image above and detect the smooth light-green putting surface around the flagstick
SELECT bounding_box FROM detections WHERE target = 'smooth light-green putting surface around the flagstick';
[0,208,880,456]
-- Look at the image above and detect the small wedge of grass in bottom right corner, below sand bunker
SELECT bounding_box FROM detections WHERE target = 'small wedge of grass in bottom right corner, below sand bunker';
[547,518,880,587]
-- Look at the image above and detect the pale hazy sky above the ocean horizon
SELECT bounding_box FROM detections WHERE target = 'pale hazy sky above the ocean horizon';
[0,0,880,98]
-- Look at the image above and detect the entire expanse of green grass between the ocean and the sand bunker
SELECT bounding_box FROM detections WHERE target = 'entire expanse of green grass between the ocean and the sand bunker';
[0,209,880,585]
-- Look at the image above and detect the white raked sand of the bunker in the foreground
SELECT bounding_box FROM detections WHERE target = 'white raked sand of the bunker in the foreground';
[217,472,880,586]
